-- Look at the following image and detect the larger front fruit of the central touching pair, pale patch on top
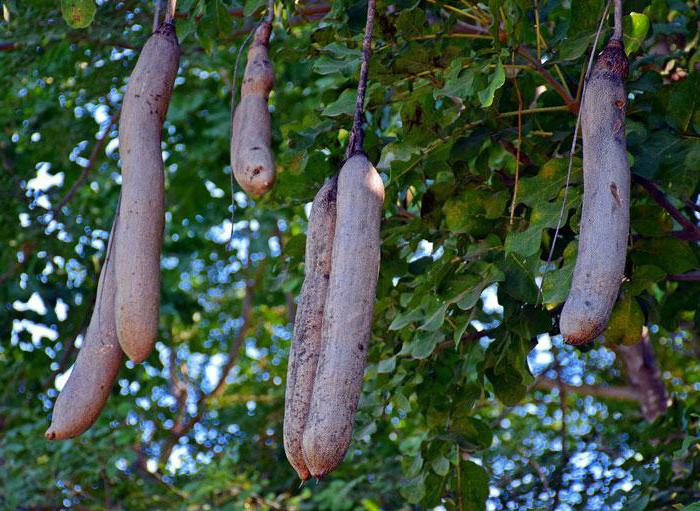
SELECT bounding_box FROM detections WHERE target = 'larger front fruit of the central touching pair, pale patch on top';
[303,154,384,478]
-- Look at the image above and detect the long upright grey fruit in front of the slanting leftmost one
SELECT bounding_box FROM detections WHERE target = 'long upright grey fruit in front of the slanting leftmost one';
[115,23,180,362]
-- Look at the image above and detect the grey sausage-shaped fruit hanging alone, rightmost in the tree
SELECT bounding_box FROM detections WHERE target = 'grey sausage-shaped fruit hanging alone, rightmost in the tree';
[559,39,630,344]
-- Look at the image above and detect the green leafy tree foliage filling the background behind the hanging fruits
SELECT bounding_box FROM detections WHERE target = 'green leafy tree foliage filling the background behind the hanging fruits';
[0,0,700,510]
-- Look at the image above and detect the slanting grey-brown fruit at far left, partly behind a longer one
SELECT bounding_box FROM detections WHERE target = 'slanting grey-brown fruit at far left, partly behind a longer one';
[45,211,122,440]
